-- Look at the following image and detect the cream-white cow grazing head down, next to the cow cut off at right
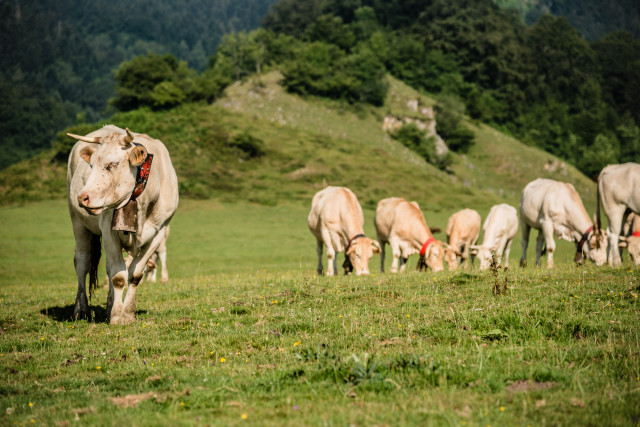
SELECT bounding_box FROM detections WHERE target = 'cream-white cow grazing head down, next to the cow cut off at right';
[520,178,606,268]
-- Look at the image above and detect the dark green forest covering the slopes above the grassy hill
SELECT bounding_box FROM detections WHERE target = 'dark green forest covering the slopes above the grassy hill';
[0,0,640,178]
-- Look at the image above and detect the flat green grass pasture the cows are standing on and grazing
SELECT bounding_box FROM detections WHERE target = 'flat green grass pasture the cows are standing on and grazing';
[0,199,640,426]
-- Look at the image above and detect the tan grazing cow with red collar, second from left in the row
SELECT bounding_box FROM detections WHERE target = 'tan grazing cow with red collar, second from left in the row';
[374,197,444,273]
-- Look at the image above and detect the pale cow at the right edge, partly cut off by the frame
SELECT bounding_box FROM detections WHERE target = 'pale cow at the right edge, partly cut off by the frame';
[596,163,640,266]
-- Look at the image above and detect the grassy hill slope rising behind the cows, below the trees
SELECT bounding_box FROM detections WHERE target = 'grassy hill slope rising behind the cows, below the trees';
[0,71,595,217]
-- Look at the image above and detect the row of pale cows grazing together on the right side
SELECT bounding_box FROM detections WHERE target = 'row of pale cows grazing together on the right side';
[308,173,640,276]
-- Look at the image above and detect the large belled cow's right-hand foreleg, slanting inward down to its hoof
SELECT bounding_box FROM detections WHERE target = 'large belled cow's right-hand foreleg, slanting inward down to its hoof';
[122,226,167,324]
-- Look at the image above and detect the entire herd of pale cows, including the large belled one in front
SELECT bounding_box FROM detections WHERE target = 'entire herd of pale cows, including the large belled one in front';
[67,125,640,324]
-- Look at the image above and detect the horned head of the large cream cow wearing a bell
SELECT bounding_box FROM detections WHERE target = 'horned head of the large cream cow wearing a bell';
[67,129,147,215]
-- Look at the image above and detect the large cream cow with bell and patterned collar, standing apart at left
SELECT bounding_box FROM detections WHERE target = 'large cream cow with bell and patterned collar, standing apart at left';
[67,125,178,324]
